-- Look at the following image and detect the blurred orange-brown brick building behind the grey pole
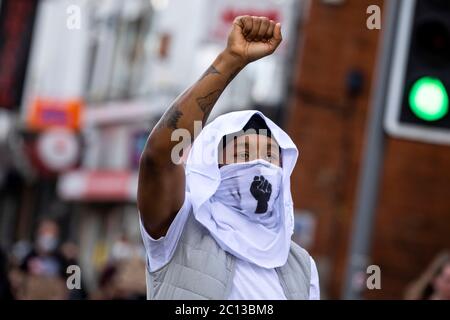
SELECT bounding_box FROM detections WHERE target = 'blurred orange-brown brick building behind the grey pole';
[285,0,450,299]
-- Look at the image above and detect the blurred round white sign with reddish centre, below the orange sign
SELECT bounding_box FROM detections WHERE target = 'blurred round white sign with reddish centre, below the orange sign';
[37,128,80,171]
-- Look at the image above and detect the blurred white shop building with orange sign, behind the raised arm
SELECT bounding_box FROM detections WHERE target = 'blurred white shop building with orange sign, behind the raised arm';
[0,0,311,290]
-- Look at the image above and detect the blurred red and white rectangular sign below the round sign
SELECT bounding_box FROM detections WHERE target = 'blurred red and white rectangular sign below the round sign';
[58,170,138,202]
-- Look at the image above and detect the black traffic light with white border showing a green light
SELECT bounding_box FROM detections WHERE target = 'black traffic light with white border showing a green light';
[385,0,450,144]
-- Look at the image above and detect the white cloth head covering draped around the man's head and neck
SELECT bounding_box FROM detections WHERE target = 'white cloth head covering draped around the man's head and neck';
[186,110,298,268]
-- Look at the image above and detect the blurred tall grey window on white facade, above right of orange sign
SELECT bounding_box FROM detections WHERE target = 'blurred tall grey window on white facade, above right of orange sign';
[86,0,152,102]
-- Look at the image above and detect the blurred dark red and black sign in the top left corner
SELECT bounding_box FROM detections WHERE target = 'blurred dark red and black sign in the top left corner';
[0,0,39,109]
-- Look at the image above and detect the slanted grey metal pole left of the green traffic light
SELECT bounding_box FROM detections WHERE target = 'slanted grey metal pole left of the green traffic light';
[343,0,402,299]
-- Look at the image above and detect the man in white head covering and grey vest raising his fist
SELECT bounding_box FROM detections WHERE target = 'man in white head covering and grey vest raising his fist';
[138,16,319,300]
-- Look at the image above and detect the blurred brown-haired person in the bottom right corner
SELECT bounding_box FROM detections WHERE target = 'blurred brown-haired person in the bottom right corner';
[405,251,450,300]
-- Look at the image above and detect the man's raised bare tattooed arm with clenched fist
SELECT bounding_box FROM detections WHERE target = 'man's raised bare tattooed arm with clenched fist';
[138,16,282,239]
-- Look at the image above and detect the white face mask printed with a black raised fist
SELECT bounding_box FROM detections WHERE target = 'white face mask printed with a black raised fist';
[213,159,283,220]
